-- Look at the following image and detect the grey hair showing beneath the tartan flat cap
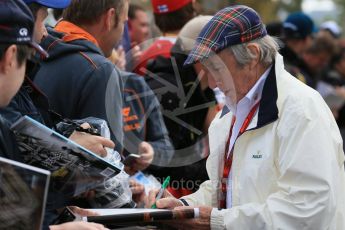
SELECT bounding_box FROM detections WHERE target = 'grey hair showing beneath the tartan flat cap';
[229,35,279,67]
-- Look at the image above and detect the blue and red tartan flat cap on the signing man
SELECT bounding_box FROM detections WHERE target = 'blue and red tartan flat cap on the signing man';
[184,5,267,65]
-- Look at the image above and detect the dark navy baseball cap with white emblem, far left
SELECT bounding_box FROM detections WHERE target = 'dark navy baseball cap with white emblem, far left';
[0,0,49,58]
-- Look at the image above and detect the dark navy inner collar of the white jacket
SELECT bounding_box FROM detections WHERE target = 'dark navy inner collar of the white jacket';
[220,59,279,129]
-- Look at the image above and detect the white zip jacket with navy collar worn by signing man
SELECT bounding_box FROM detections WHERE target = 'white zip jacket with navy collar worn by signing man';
[183,54,345,230]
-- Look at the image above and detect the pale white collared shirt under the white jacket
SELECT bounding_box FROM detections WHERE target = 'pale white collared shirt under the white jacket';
[226,66,272,208]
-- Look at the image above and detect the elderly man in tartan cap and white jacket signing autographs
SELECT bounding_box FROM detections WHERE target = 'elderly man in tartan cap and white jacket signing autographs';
[150,6,345,229]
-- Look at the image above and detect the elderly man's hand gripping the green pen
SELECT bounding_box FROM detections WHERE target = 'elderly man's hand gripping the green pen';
[145,189,183,209]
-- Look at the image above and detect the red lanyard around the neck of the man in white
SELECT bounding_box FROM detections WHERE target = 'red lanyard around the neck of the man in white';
[218,101,260,208]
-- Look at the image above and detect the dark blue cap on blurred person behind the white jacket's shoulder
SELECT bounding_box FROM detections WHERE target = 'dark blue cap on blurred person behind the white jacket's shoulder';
[283,12,315,39]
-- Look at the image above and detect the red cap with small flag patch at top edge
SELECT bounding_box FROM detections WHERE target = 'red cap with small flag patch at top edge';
[151,0,192,14]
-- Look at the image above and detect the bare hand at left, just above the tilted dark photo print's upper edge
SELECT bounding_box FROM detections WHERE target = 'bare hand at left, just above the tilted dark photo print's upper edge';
[69,123,115,157]
